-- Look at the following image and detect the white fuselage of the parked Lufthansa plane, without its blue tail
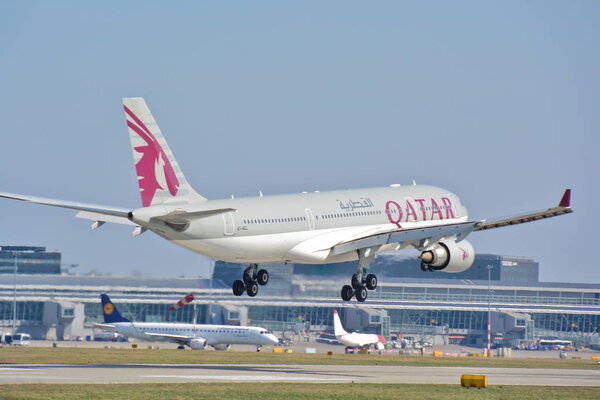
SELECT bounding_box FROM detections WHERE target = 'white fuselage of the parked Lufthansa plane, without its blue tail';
[105,322,278,346]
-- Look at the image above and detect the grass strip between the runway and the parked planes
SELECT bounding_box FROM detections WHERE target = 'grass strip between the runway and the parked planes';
[0,347,600,369]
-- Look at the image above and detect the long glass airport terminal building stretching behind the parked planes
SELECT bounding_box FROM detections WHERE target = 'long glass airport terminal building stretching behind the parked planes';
[0,247,600,346]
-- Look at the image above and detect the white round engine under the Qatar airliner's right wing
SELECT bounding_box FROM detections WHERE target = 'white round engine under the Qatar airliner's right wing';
[419,239,475,273]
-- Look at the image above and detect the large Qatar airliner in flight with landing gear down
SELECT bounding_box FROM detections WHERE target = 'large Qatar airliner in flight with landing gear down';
[0,97,573,302]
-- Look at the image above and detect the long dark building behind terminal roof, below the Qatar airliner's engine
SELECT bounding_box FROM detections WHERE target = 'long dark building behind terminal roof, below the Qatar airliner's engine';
[294,253,540,283]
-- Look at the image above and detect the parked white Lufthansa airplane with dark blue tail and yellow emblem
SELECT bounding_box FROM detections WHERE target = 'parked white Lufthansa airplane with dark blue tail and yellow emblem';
[94,294,279,350]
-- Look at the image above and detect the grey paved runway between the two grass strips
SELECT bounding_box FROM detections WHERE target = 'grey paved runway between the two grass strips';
[0,364,600,386]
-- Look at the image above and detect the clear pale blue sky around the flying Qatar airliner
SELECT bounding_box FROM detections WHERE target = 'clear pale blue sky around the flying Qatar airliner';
[0,0,600,283]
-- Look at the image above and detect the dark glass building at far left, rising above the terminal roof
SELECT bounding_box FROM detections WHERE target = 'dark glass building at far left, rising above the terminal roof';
[0,246,61,274]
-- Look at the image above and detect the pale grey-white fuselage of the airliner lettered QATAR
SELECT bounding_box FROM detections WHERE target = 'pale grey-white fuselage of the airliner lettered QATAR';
[132,185,468,264]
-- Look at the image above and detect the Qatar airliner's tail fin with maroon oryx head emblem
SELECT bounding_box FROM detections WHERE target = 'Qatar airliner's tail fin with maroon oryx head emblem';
[123,97,206,207]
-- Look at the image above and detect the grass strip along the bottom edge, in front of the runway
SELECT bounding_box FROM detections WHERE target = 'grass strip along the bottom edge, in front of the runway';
[0,383,600,400]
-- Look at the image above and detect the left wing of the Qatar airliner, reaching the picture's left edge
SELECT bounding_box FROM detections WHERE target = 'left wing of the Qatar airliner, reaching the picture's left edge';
[0,192,136,225]
